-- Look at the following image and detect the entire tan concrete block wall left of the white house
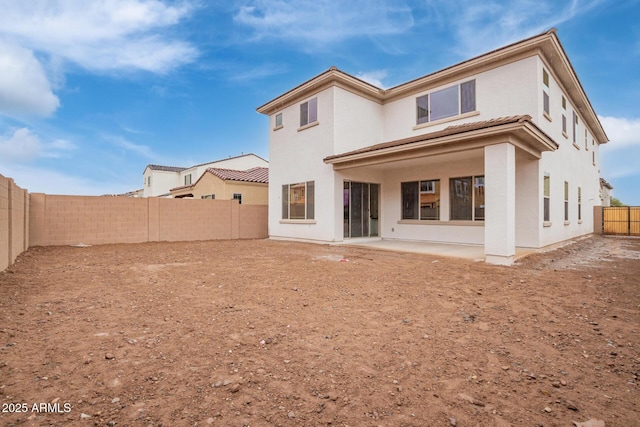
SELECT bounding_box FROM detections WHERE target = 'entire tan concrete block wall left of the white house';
[0,175,268,271]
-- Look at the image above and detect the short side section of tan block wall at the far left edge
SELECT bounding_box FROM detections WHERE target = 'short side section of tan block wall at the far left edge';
[0,175,29,271]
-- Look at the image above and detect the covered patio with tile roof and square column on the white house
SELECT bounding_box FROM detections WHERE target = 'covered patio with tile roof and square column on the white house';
[324,116,557,265]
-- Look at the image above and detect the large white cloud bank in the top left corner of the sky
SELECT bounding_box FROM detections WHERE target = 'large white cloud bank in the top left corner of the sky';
[0,0,198,73]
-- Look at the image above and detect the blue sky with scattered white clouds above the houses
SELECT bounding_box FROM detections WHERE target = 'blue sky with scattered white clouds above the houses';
[0,0,640,205]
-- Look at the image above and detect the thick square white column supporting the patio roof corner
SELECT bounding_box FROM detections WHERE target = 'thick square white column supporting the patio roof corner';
[484,142,516,265]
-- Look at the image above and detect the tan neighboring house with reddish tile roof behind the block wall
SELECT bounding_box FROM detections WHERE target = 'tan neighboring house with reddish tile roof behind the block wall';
[171,168,269,205]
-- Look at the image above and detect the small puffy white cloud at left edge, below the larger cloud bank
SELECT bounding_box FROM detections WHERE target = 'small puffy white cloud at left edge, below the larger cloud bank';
[0,40,60,117]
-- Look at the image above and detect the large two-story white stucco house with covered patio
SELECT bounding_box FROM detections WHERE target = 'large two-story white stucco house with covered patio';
[257,30,608,265]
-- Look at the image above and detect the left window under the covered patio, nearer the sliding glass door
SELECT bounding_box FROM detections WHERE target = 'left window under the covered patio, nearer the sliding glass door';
[401,179,440,220]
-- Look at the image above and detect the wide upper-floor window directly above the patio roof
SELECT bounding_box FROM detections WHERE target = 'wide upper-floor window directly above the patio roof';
[416,80,476,124]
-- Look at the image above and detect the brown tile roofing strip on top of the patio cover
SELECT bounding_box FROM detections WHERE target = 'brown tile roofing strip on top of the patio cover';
[324,115,533,161]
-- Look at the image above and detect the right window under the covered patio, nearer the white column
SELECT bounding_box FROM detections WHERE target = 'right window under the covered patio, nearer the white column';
[449,176,484,221]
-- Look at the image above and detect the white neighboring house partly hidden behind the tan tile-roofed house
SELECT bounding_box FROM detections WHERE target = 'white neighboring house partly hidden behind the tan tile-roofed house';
[143,154,269,197]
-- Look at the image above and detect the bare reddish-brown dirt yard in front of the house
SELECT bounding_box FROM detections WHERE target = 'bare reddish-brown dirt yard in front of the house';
[0,237,640,427]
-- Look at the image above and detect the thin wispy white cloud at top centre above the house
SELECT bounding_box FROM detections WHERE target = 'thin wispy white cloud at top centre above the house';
[234,0,414,50]
